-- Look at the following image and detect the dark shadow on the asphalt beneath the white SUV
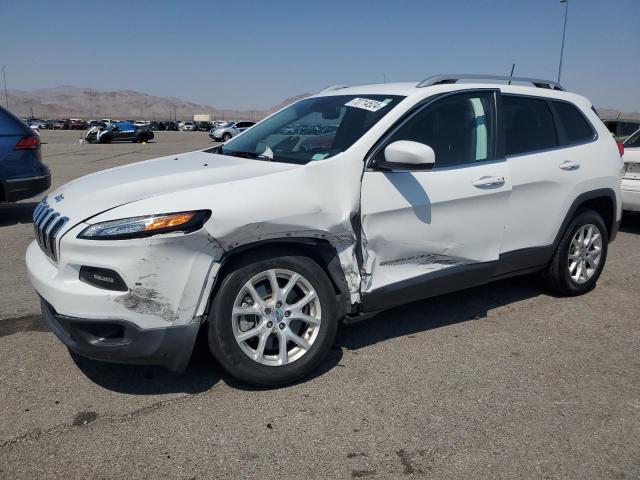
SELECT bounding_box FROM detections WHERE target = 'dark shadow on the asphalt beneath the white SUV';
[71,276,548,395]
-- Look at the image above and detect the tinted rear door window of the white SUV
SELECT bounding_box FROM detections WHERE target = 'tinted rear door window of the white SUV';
[502,95,558,156]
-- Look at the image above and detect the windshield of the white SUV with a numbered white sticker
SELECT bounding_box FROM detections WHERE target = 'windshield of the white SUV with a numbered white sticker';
[216,95,404,164]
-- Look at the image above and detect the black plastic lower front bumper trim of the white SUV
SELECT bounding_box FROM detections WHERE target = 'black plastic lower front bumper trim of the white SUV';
[41,299,200,373]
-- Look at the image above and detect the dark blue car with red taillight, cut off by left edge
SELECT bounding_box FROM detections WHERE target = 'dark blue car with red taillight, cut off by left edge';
[0,107,51,202]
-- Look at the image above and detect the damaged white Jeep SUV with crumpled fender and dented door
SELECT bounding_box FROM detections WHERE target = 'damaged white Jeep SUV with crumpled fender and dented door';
[27,75,623,385]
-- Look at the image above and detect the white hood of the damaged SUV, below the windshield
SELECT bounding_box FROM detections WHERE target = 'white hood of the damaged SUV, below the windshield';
[48,151,301,222]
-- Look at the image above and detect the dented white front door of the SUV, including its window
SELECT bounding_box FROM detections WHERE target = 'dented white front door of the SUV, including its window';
[361,91,511,296]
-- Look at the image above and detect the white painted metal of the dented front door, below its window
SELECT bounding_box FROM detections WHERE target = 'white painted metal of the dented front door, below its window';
[362,159,511,290]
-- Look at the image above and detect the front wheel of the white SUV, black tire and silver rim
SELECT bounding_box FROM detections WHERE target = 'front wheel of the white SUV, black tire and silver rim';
[208,255,338,387]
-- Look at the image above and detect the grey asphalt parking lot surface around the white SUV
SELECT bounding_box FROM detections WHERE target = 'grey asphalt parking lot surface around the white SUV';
[0,131,640,479]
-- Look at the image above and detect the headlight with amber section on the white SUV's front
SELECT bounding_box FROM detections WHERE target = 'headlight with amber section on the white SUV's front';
[78,210,211,240]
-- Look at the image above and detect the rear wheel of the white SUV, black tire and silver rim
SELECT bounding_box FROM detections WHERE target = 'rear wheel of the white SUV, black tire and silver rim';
[545,210,609,296]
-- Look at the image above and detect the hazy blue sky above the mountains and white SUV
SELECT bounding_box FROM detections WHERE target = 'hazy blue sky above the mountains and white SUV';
[0,0,640,111]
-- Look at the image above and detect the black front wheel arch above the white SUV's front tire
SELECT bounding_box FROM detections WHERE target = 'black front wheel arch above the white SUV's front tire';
[207,237,352,317]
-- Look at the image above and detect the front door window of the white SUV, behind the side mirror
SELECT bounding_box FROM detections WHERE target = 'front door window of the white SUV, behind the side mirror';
[375,92,495,167]
